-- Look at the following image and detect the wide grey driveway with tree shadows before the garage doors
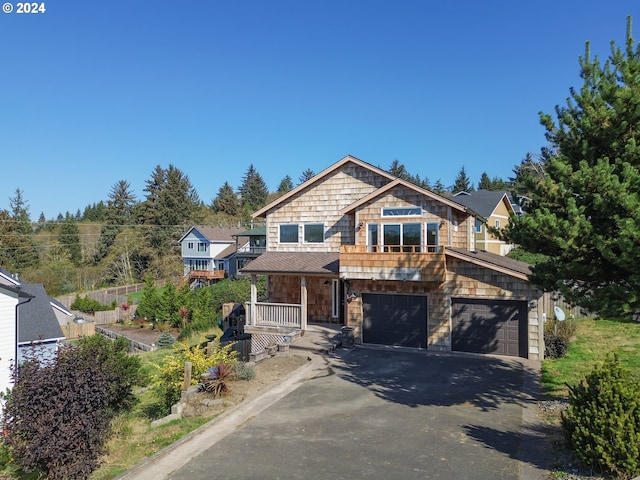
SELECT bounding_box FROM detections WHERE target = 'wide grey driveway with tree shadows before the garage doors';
[125,348,547,480]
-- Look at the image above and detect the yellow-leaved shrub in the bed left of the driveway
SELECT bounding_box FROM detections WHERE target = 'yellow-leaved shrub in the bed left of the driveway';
[154,340,238,409]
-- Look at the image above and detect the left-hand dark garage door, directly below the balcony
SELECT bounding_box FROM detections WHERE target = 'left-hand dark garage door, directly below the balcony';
[362,293,427,348]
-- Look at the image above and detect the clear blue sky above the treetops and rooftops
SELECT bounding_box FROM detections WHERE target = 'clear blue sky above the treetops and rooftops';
[0,0,640,220]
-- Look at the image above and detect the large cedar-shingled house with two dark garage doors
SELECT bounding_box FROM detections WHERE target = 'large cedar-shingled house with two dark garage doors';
[241,156,544,359]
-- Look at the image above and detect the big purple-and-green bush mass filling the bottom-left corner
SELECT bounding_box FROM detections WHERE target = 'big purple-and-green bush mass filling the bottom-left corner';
[2,335,140,480]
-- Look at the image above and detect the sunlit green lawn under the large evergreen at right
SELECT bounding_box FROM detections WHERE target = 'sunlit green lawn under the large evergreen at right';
[542,319,640,397]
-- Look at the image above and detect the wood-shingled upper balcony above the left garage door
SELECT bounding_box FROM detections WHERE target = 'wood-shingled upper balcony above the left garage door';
[340,245,446,283]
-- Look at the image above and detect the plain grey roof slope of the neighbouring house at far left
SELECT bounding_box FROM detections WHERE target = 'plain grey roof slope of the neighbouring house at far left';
[18,283,64,343]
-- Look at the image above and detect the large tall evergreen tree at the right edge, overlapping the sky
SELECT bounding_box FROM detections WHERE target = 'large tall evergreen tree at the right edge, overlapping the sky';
[506,18,640,317]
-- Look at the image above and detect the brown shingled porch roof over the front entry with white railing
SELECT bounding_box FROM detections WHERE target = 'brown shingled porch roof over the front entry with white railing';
[240,252,340,275]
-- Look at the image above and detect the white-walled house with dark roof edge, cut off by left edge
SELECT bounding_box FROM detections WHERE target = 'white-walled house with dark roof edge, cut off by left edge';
[0,283,33,393]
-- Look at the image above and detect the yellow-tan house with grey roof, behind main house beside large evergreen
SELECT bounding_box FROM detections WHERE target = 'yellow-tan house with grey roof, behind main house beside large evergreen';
[452,190,516,255]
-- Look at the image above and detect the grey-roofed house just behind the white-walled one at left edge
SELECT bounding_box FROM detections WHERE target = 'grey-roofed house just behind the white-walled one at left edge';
[0,270,67,370]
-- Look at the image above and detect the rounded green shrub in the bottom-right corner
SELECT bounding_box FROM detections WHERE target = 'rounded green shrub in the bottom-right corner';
[562,355,640,478]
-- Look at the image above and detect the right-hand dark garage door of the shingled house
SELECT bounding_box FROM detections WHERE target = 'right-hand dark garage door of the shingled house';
[451,298,527,358]
